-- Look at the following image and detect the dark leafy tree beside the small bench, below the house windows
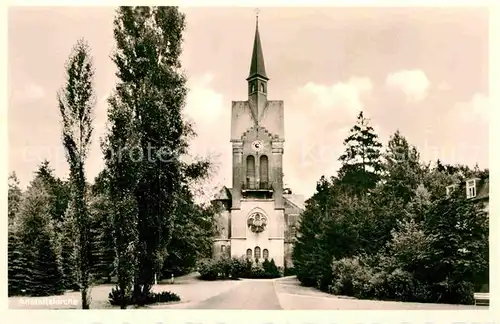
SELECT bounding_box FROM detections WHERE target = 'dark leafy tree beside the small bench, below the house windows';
[424,190,489,303]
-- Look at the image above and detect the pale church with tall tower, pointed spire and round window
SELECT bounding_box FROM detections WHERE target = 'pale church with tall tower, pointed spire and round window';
[213,16,304,267]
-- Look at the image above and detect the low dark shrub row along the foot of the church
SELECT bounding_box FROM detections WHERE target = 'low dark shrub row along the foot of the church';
[198,258,282,280]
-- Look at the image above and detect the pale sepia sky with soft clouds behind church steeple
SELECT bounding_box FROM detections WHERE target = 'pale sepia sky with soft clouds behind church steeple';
[8,7,489,197]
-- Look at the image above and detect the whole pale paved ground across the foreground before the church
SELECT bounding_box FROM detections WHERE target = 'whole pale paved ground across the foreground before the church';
[9,276,488,310]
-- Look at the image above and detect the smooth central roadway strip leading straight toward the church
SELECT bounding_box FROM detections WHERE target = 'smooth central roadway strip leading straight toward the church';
[187,279,281,310]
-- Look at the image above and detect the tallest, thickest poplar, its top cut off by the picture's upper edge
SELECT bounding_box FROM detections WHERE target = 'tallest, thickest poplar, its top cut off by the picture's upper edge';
[108,7,213,294]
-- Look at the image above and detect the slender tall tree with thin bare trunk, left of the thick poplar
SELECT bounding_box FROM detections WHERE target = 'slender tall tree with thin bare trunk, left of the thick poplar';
[58,39,95,309]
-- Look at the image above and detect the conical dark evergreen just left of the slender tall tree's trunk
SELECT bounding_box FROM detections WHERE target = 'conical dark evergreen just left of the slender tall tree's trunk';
[19,177,63,296]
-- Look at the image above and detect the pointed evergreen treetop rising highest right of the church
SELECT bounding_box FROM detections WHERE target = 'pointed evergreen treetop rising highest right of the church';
[338,112,382,194]
